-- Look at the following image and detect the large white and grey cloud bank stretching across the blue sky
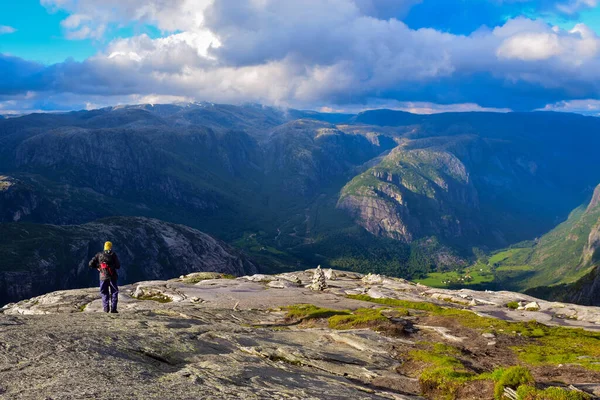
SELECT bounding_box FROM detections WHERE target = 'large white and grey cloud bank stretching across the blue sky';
[0,0,600,112]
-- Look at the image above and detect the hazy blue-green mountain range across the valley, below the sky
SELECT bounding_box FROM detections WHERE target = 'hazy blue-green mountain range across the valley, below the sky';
[0,103,600,300]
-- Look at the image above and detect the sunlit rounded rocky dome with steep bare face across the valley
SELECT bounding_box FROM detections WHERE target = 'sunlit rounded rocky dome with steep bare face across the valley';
[338,146,479,242]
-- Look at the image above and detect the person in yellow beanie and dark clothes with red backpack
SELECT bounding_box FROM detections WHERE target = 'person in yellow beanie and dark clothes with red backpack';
[90,242,121,314]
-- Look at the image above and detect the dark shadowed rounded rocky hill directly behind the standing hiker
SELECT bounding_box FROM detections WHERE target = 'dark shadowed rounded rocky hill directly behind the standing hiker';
[0,217,256,303]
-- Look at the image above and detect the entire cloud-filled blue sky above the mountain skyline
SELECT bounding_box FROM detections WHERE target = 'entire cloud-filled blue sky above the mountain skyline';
[0,0,600,115]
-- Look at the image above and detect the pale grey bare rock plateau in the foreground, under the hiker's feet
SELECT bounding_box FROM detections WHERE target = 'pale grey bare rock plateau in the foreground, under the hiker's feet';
[0,270,600,400]
